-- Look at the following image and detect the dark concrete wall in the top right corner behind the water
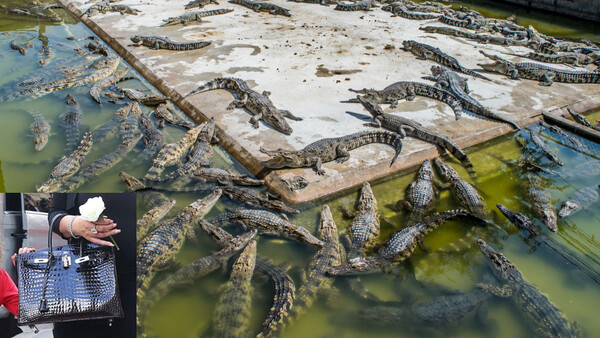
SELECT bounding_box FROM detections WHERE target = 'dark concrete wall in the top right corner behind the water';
[503,0,600,22]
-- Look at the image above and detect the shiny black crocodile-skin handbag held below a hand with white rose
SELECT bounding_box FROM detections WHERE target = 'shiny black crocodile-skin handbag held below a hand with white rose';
[17,224,123,325]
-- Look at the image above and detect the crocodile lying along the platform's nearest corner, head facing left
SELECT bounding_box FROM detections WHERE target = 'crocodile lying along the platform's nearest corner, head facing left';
[260,131,402,175]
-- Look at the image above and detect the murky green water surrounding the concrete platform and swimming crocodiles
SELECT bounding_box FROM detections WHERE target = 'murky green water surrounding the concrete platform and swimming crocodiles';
[0,0,600,337]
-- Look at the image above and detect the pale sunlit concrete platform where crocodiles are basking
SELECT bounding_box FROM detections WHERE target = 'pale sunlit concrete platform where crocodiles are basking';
[59,0,600,203]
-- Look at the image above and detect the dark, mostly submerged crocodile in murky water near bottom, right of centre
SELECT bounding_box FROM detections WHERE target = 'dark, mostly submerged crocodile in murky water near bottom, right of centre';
[358,288,492,328]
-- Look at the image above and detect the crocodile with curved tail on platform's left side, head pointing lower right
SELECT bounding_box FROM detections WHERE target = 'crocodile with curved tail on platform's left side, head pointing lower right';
[185,77,302,135]
